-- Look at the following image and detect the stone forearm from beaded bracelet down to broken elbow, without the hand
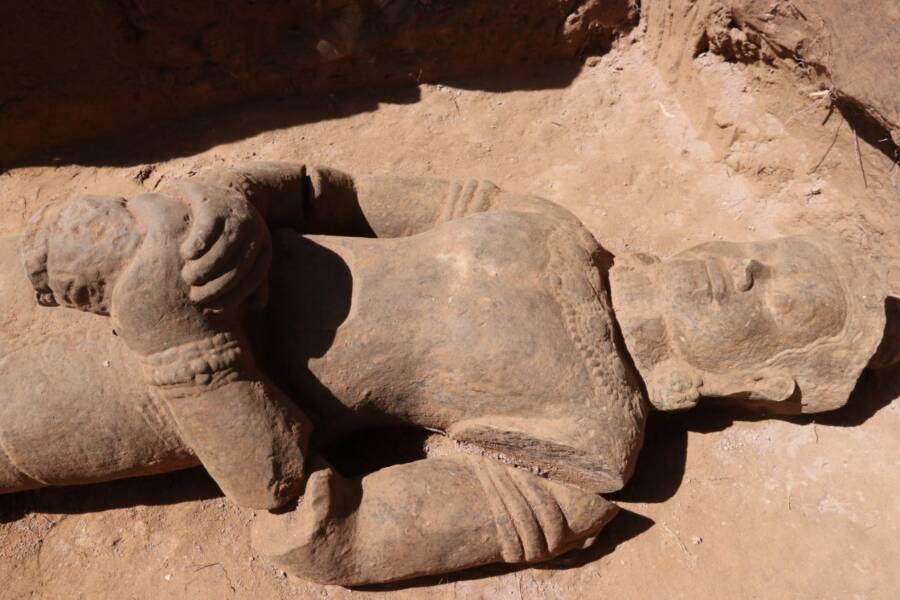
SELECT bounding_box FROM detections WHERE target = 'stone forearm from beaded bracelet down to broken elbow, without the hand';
[144,334,312,509]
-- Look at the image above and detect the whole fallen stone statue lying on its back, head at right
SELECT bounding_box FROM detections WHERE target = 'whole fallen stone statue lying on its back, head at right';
[0,163,900,585]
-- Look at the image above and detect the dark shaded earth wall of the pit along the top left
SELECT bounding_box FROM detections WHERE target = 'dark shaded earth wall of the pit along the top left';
[0,0,637,165]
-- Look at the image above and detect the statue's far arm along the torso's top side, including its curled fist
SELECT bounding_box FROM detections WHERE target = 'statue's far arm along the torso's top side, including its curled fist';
[166,162,577,306]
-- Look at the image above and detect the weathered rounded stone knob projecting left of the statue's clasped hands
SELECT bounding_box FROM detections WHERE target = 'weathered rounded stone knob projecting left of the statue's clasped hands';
[22,196,141,315]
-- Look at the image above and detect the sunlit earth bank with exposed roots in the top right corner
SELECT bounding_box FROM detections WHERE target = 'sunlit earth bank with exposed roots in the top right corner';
[641,0,900,162]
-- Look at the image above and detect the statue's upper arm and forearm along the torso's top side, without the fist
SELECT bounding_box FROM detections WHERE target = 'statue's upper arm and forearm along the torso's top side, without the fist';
[162,162,574,238]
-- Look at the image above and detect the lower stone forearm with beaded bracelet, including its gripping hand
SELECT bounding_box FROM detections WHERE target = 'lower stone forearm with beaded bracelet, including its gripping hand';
[111,195,312,509]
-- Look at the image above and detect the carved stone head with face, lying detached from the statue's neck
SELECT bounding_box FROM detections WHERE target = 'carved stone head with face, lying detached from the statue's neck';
[610,235,886,413]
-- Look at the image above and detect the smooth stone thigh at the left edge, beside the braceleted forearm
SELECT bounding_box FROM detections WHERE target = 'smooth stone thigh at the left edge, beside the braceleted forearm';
[0,328,198,493]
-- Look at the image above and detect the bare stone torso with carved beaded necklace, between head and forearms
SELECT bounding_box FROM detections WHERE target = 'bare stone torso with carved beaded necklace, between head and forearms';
[270,213,644,491]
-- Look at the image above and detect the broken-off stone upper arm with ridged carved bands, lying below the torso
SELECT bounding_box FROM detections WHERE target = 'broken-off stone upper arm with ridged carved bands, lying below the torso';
[253,455,618,586]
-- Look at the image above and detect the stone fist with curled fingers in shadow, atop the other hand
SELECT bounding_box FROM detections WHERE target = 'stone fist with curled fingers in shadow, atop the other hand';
[176,181,271,307]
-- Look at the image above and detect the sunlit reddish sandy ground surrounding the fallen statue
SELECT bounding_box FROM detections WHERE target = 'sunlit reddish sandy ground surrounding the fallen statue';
[0,41,900,600]
